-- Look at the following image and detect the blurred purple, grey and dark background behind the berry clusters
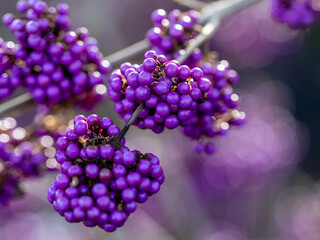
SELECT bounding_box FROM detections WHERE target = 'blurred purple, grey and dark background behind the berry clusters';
[0,0,320,240]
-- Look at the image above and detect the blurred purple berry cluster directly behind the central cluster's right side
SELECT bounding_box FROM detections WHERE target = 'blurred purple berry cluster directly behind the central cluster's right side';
[183,54,245,154]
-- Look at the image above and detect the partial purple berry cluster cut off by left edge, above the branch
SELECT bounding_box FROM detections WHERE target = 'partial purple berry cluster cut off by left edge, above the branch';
[0,38,22,101]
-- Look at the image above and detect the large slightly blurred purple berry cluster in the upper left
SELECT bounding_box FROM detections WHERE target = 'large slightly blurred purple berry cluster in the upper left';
[3,0,110,105]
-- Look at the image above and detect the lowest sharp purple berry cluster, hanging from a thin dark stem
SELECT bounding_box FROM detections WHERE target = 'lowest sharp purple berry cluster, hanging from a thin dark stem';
[48,115,164,232]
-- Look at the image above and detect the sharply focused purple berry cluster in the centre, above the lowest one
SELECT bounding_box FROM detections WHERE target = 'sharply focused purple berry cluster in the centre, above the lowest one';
[108,50,211,133]
